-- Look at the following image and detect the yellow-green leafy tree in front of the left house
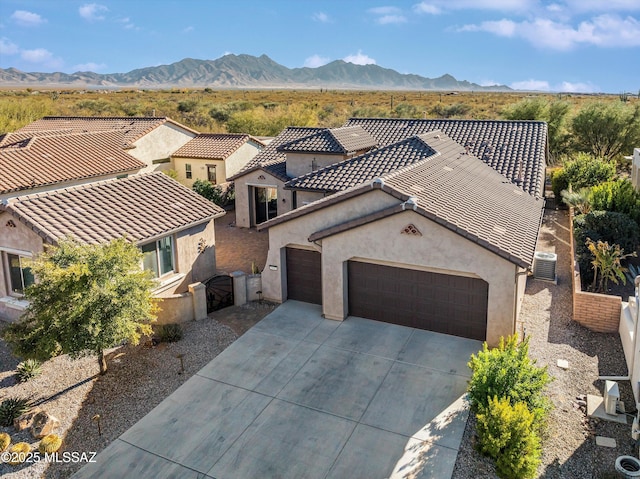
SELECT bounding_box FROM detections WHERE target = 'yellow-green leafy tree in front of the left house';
[4,238,156,374]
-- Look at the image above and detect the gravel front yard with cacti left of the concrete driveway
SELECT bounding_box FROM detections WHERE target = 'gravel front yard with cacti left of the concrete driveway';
[0,302,274,479]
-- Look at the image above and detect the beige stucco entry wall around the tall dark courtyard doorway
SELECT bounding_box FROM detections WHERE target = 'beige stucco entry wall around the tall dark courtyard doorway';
[235,170,293,228]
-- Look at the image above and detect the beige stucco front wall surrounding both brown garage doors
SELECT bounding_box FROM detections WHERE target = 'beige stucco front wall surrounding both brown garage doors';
[262,191,517,345]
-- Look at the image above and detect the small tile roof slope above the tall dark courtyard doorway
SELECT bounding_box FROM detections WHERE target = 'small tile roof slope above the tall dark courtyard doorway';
[227,126,324,181]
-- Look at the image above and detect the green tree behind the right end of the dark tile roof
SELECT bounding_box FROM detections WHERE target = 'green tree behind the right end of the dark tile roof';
[502,98,570,158]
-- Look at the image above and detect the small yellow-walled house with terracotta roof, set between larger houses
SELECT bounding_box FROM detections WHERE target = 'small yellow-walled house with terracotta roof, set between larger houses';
[171,133,265,188]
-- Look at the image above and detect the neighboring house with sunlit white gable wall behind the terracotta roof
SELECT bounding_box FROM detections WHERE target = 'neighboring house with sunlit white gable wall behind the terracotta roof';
[16,116,198,172]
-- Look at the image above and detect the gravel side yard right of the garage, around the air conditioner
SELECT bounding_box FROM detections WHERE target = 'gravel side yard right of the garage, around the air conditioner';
[453,210,638,479]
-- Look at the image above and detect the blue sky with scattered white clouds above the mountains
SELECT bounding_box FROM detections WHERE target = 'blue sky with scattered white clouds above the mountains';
[0,0,640,93]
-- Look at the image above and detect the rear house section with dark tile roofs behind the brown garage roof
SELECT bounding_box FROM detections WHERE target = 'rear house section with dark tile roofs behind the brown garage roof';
[230,118,547,227]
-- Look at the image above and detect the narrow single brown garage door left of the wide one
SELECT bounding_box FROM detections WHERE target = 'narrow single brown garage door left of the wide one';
[287,248,322,304]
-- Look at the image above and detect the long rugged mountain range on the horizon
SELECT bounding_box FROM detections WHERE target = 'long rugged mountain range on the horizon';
[0,55,510,91]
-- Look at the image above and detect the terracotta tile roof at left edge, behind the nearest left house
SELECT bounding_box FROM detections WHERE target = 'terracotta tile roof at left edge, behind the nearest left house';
[0,131,145,194]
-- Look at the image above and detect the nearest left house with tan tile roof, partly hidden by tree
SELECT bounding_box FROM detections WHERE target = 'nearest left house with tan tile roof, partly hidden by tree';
[0,172,224,320]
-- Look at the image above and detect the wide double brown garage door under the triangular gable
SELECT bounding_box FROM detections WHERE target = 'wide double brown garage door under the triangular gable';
[349,261,489,341]
